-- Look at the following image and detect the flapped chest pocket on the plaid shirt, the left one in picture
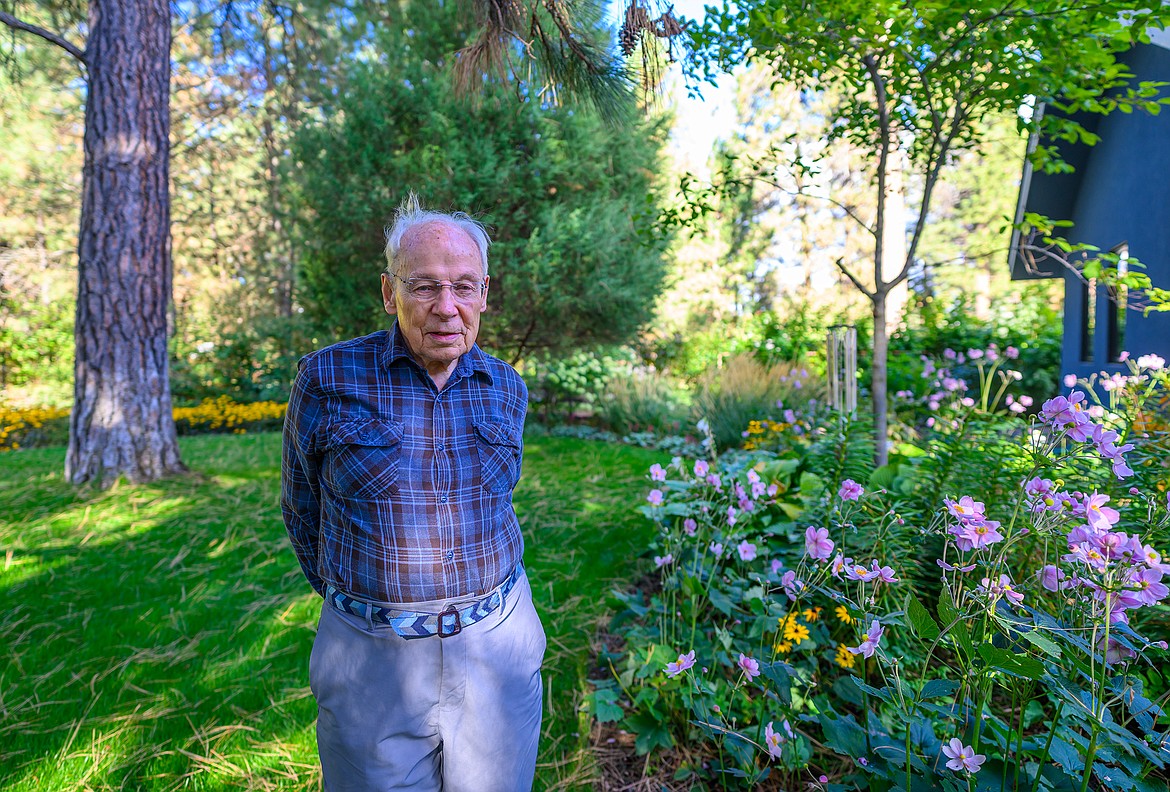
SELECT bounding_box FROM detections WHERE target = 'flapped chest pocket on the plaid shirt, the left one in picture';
[325,420,404,498]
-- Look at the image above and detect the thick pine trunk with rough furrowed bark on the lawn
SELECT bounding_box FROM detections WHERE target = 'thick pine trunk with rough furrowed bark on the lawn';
[66,0,184,487]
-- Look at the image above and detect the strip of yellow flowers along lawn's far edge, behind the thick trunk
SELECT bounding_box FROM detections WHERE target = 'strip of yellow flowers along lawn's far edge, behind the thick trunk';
[0,397,285,452]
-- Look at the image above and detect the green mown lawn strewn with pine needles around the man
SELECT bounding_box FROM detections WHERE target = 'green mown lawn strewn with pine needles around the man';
[0,434,661,790]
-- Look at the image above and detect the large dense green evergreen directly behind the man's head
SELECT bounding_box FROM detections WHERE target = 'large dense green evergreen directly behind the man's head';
[295,7,666,360]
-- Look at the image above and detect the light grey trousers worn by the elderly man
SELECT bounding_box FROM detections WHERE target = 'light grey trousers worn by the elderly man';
[309,573,545,792]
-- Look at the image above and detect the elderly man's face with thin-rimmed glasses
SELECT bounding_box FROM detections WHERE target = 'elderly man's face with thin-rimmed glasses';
[381,221,488,379]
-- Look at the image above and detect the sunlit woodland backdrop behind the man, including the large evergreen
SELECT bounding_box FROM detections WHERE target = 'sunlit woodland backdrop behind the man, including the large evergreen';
[0,2,1059,421]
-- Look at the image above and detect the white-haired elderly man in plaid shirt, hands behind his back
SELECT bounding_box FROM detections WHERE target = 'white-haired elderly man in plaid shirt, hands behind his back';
[281,195,545,792]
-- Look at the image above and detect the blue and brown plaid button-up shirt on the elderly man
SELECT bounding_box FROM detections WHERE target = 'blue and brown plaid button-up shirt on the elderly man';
[281,323,528,602]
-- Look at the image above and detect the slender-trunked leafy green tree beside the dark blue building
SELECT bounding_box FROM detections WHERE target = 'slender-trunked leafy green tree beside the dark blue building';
[693,0,1168,464]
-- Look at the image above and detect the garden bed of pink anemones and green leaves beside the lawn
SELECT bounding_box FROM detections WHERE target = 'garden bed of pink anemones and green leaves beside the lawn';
[611,347,1170,792]
